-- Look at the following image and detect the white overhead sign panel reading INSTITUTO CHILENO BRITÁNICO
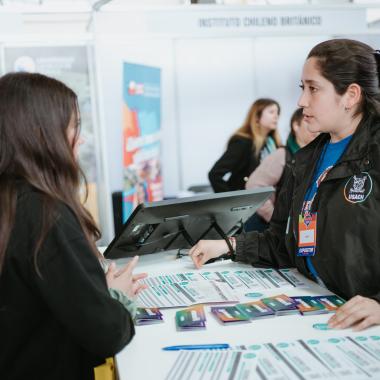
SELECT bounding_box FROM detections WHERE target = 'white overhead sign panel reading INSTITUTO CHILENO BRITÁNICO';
[96,6,367,37]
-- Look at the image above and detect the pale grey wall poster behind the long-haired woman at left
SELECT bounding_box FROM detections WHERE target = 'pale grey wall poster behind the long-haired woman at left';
[4,45,99,225]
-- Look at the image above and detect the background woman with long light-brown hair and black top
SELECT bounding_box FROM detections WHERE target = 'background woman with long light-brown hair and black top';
[208,99,281,193]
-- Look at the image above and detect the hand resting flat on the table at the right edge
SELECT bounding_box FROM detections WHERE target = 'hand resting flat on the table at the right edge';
[328,296,380,331]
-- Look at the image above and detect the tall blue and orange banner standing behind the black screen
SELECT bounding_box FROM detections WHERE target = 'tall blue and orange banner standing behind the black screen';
[122,62,163,221]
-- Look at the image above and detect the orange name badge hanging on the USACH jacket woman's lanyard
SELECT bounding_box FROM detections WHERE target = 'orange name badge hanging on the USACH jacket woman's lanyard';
[297,212,317,257]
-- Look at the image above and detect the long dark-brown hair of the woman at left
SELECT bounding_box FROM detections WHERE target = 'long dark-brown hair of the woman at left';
[0,73,100,272]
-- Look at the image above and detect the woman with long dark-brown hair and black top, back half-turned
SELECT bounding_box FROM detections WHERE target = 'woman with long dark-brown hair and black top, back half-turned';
[0,73,145,380]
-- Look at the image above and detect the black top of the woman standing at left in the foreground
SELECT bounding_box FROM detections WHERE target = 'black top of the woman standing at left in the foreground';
[0,186,134,380]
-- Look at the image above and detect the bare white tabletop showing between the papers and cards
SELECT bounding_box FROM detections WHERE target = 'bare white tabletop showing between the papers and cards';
[116,251,380,380]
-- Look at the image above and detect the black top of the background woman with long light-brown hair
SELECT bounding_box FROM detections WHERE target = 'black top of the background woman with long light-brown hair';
[208,135,260,193]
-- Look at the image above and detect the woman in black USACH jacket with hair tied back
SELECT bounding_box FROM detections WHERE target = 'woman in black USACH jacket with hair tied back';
[190,39,380,330]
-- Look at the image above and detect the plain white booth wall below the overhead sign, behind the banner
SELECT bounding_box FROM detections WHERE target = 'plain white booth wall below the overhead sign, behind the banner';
[96,35,328,196]
